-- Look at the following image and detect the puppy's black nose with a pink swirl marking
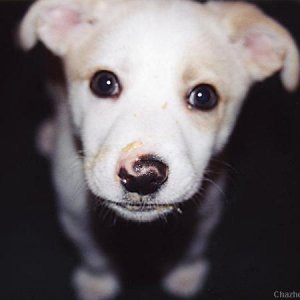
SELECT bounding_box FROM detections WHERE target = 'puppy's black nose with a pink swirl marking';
[118,155,169,195]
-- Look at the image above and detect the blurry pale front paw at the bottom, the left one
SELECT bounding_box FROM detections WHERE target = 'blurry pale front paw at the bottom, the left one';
[73,267,120,300]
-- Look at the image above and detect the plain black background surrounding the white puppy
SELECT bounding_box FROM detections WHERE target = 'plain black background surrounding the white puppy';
[0,1,300,300]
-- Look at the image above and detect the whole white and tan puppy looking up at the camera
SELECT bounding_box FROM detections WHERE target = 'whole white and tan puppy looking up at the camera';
[20,0,299,300]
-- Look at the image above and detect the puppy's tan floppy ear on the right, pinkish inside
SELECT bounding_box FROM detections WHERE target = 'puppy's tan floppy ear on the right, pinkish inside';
[207,2,299,91]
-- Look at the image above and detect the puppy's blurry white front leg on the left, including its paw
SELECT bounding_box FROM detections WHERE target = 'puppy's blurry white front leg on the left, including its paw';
[51,105,119,300]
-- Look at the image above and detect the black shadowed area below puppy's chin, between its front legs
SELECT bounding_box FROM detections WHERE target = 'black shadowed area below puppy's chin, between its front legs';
[89,195,201,282]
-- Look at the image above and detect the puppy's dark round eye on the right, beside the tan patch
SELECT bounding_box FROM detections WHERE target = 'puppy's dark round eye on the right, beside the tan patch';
[188,84,218,110]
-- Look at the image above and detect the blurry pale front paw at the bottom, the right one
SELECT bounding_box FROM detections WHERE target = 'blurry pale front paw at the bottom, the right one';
[162,260,208,298]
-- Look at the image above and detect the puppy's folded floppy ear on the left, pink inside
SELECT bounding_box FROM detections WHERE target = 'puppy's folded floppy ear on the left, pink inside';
[19,0,92,56]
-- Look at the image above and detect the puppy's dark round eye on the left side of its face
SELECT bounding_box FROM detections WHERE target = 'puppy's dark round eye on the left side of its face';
[90,71,121,98]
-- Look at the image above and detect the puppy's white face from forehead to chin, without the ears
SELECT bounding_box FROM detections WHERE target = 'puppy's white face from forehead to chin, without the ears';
[66,7,249,220]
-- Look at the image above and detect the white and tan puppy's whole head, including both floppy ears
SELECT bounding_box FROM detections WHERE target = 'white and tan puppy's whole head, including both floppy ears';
[20,0,299,221]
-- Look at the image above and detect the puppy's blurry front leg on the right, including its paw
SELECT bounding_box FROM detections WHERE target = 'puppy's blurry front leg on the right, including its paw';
[162,175,225,297]
